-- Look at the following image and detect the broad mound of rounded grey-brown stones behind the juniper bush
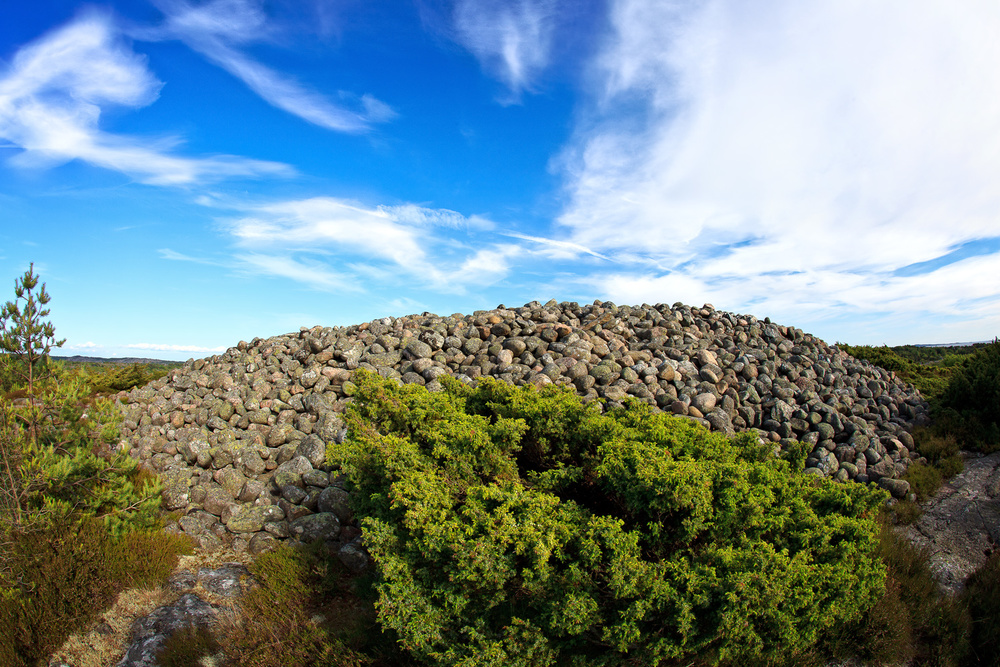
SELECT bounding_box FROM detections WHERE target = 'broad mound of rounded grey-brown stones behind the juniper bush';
[118,301,927,556]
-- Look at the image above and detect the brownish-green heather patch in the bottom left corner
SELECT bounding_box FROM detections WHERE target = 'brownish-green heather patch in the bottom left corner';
[0,517,190,665]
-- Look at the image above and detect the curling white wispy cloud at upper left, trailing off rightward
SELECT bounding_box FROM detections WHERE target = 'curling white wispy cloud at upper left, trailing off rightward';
[0,12,291,185]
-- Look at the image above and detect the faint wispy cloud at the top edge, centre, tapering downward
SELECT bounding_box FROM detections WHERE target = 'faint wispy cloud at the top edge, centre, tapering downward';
[453,0,558,99]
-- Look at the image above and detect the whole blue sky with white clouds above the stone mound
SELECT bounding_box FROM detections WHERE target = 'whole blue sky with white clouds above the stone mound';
[0,0,1000,359]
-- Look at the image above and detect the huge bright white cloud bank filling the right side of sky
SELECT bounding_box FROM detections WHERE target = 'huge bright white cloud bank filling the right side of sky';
[558,0,1000,336]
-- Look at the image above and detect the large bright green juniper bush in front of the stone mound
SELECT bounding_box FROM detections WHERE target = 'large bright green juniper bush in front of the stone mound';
[329,373,885,665]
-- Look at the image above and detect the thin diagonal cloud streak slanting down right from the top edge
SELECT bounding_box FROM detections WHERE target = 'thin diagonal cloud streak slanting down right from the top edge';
[146,0,396,132]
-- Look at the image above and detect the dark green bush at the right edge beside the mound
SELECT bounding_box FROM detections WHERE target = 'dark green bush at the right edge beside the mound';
[937,340,1000,452]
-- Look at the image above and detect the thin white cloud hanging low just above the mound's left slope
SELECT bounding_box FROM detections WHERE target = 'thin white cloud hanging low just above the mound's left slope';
[216,197,524,293]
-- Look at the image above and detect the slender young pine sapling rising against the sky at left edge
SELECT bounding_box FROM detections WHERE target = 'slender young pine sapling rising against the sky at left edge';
[0,262,66,442]
